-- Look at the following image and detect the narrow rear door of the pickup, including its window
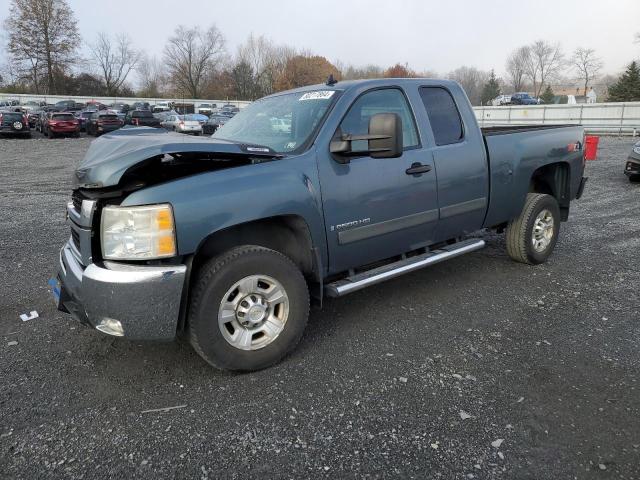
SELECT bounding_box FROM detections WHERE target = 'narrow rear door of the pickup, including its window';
[419,86,489,241]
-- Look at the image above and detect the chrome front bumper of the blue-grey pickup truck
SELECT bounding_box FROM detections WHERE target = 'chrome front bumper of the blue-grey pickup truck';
[53,242,187,340]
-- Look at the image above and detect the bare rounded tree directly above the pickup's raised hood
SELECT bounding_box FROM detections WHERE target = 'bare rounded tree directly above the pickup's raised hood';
[164,25,225,98]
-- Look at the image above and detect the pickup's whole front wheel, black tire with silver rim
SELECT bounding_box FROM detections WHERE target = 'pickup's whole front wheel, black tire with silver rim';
[188,245,309,371]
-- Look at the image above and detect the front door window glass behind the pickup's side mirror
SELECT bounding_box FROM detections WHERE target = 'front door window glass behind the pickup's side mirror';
[340,88,419,152]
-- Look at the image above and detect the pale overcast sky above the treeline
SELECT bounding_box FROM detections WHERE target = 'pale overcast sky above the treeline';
[0,0,640,78]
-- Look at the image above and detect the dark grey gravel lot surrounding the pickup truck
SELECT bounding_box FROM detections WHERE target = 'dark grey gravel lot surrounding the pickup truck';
[0,133,640,479]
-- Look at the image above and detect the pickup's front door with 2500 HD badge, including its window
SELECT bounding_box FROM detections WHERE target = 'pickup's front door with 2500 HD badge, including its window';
[318,88,438,273]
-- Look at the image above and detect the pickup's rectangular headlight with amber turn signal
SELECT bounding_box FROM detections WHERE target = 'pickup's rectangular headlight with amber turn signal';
[100,204,177,260]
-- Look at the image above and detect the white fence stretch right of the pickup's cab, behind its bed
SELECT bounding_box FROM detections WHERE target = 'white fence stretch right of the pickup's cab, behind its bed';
[473,102,640,136]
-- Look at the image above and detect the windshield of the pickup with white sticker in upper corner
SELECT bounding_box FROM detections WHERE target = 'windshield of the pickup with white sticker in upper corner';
[212,90,336,153]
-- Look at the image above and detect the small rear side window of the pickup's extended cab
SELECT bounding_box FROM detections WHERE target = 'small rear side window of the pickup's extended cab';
[420,87,464,146]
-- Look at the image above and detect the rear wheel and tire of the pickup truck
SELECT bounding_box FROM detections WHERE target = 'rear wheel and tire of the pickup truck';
[506,193,560,265]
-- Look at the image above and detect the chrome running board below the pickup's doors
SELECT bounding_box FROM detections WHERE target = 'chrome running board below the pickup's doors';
[324,238,485,297]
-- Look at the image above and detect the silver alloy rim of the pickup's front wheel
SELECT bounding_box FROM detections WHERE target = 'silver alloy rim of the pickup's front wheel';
[218,275,289,350]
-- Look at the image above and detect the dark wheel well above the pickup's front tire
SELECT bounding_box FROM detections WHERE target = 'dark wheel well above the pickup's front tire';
[193,215,317,276]
